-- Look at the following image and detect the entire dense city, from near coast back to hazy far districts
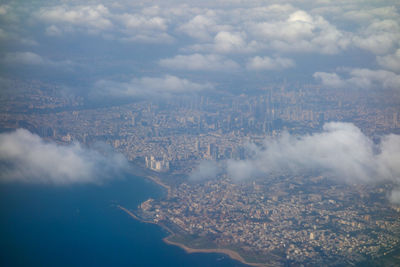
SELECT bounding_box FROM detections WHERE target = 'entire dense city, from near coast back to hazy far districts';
[0,82,400,266]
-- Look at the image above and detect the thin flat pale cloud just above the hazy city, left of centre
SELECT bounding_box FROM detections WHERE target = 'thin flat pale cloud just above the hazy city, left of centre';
[93,75,213,97]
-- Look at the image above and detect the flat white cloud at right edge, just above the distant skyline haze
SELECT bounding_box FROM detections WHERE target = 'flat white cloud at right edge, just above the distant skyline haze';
[313,69,400,89]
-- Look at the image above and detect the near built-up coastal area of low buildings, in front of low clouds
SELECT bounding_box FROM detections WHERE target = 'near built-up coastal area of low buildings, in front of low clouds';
[138,176,400,266]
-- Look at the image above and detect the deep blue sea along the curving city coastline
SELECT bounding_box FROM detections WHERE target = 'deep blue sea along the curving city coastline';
[0,175,244,266]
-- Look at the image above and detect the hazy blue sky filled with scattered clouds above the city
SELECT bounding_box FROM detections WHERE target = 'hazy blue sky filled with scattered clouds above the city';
[0,0,400,97]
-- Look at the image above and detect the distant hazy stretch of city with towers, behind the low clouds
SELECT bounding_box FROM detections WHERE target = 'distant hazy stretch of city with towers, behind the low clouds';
[0,82,400,176]
